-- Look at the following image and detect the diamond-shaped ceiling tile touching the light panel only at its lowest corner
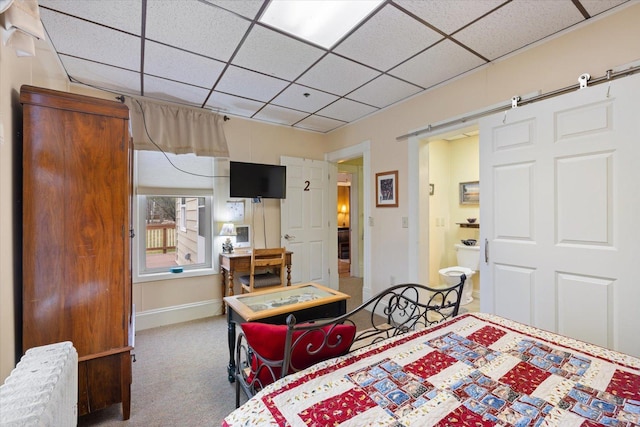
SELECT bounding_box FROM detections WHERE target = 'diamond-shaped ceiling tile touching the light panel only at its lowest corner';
[297,54,380,95]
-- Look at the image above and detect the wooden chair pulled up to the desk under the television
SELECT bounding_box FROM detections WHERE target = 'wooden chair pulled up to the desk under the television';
[238,248,287,293]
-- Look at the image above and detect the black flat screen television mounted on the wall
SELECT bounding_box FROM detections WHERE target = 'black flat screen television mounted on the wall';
[229,162,287,199]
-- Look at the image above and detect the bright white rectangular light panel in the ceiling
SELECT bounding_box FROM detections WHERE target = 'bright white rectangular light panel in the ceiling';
[260,0,382,49]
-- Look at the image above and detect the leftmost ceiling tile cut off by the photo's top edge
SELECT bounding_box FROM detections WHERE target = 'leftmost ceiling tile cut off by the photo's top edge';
[38,0,142,36]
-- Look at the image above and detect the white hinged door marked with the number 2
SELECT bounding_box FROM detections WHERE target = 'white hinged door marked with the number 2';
[280,156,330,286]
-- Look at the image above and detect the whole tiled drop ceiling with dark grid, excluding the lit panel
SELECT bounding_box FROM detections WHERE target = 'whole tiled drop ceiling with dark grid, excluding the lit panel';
[39,0,627,133]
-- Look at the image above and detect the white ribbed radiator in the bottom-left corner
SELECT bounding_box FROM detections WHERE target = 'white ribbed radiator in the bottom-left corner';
[0,341,78,427]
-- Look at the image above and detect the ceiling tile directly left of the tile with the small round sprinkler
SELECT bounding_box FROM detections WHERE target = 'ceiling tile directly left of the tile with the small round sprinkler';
[215,66,288,101]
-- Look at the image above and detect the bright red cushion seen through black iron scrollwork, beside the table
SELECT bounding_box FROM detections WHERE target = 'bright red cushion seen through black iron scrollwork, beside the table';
[241,322,356,386]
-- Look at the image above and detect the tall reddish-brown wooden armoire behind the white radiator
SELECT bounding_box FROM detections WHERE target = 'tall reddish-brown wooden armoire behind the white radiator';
[20,86,134,419]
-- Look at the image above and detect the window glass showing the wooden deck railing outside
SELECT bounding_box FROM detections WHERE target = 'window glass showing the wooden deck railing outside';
[138,195,212,274]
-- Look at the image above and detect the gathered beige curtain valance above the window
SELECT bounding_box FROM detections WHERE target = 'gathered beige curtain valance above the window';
[125,96,229,157]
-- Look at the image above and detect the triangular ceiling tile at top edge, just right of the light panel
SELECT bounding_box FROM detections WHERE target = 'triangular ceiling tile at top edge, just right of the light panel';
[394,0,504,34]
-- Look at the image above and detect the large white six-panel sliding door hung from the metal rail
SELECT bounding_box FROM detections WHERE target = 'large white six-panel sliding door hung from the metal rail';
[480,76,640,356]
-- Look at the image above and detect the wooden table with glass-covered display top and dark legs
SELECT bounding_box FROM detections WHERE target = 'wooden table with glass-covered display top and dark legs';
[224,283,350,382]
